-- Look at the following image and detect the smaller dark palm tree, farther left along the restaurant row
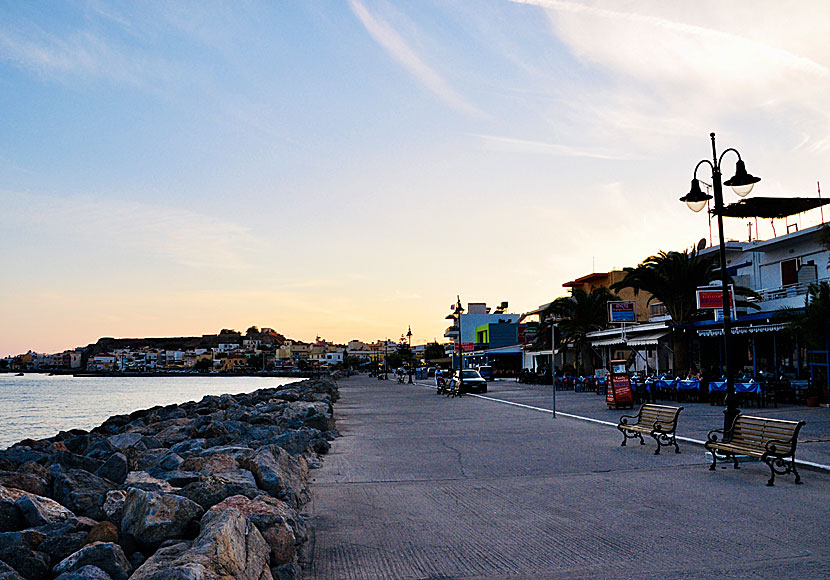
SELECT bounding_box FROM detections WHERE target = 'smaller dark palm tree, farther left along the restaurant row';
[537,287,617,374]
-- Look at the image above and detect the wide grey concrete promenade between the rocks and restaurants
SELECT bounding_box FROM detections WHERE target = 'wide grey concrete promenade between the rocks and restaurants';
[309,376,830,580]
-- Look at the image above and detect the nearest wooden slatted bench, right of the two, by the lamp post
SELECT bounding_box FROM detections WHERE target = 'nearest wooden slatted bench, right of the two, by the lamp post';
[705,415,804,485]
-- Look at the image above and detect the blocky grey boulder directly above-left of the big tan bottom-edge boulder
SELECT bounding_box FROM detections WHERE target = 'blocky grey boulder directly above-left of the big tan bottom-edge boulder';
[121,488,204,545]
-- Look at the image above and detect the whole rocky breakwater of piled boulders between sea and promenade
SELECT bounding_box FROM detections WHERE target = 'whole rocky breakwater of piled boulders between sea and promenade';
[0,378,337,580]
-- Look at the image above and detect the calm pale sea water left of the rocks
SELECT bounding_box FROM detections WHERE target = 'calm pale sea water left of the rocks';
[0,374,301,449]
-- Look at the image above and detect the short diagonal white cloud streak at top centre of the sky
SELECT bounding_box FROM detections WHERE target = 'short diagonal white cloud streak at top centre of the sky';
[350,0,483,116]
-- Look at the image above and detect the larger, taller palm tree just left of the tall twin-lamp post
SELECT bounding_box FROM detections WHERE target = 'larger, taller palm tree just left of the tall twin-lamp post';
[611,248,758,370]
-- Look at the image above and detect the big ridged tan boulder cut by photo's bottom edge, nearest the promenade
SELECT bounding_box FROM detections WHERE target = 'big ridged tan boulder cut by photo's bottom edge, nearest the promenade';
[130,509,273,580]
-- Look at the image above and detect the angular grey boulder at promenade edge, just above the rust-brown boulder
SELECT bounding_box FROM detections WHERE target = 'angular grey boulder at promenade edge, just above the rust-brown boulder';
[240,445,308,507]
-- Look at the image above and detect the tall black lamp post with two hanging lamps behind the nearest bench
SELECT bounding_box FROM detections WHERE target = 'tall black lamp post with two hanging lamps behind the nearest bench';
[680,133,761,437]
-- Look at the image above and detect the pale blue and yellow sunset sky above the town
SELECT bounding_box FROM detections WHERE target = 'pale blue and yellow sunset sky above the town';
[0,0,830,356]
